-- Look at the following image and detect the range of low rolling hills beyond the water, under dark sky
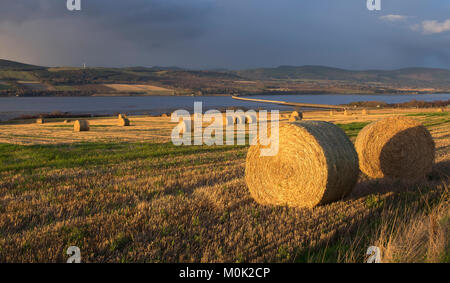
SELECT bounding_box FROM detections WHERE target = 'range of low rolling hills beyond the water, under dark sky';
[0,59,450,96]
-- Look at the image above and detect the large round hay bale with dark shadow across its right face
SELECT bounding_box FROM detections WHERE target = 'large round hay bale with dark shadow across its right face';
[355,116,435,180]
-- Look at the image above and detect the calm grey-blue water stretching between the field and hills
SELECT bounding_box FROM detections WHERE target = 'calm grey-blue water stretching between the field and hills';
[0,94,450,120]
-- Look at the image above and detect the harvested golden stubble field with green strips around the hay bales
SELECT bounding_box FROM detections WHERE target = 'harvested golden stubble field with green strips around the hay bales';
[0,110,450,262]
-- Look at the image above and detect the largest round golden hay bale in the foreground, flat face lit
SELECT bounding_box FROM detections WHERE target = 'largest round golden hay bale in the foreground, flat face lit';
[245,121,359,208]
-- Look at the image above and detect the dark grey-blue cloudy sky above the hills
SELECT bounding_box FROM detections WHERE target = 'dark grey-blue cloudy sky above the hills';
[0,0,450,70]
